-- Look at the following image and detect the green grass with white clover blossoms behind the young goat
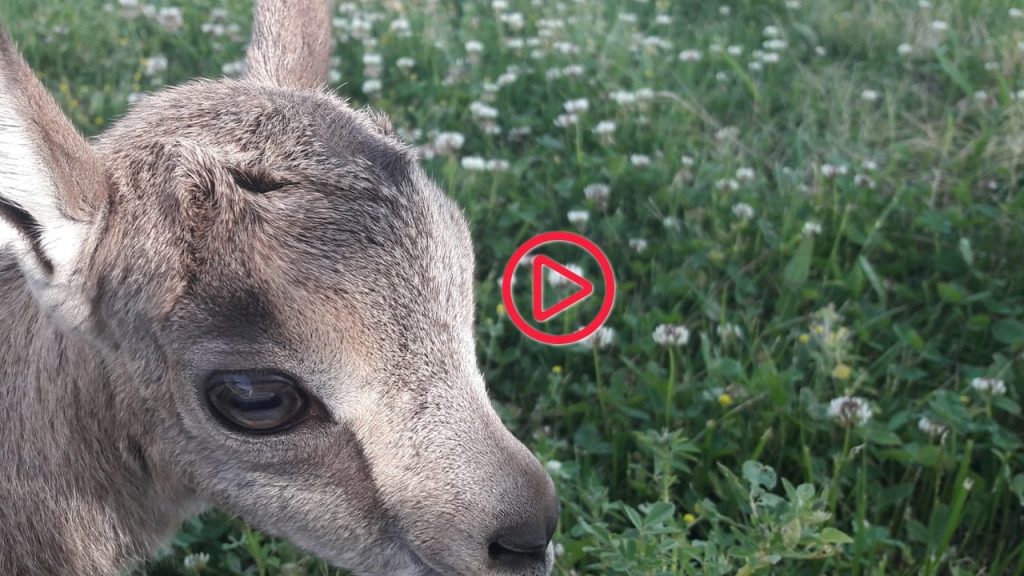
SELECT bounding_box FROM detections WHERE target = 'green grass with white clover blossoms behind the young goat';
[0,0,1024,576]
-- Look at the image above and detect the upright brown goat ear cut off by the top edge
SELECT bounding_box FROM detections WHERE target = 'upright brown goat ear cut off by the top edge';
[246,0,332,88]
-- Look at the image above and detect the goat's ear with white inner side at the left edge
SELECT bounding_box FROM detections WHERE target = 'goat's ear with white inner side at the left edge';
[0,27,109,317]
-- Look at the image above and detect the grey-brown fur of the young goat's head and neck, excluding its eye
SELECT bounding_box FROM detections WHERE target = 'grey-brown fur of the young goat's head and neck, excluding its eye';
[0,0,557,576]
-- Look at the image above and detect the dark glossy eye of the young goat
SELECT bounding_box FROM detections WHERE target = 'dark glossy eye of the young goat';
[206,372,309,435]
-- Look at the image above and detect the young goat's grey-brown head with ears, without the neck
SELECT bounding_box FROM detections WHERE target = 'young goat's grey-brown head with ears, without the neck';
[0,2,558,575]
